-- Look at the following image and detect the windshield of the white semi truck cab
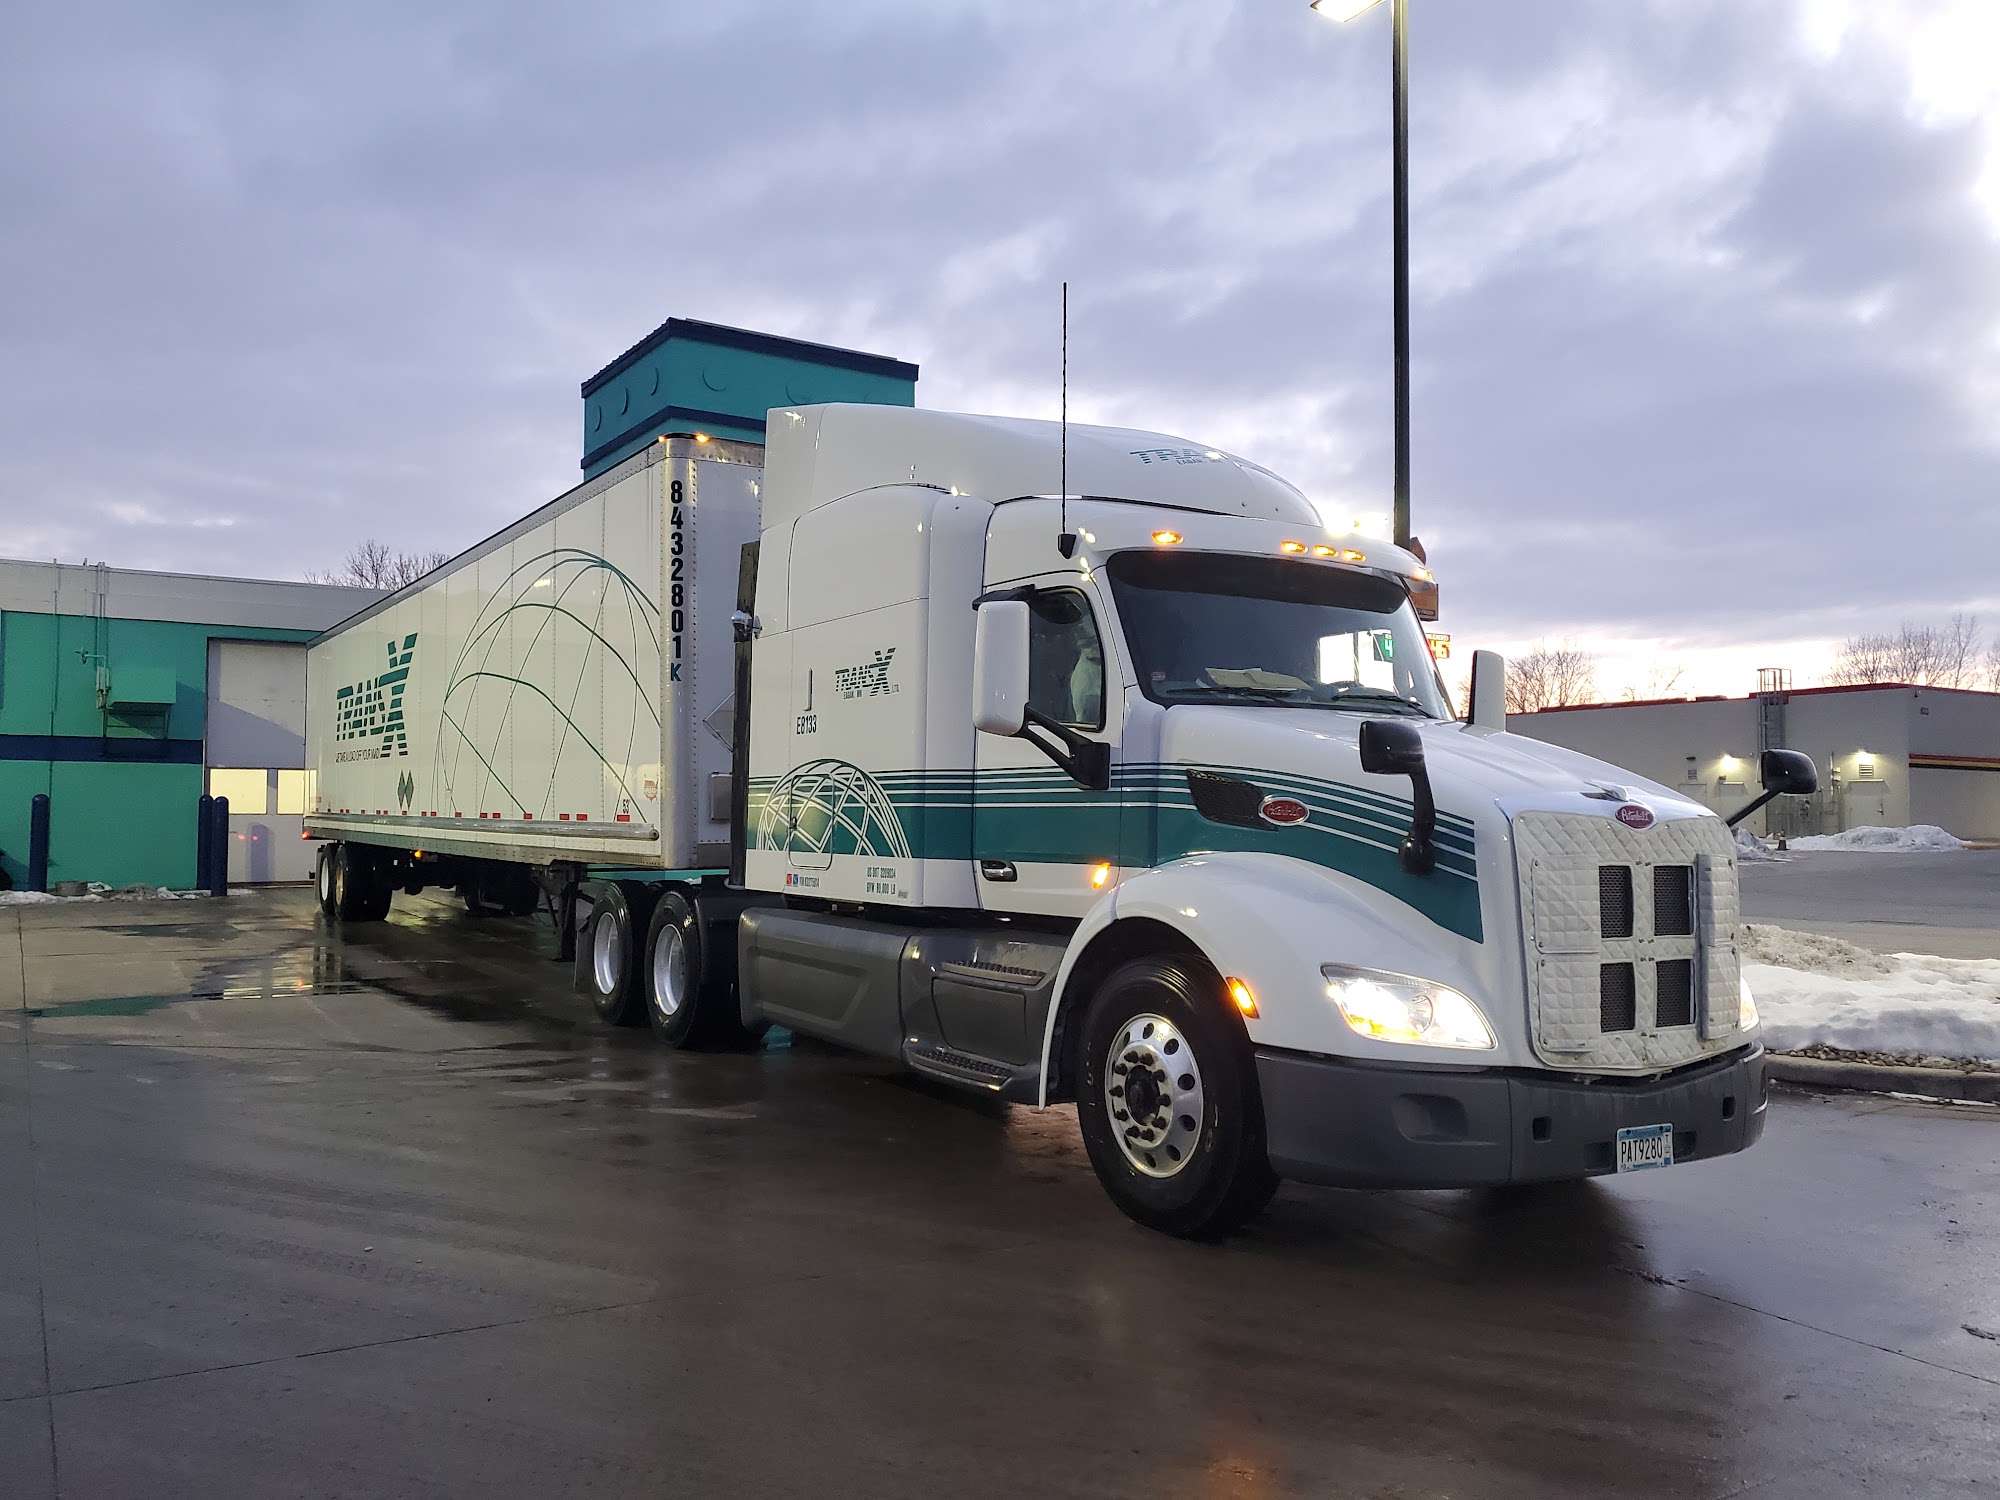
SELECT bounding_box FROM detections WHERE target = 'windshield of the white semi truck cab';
[1106,550,1450,718]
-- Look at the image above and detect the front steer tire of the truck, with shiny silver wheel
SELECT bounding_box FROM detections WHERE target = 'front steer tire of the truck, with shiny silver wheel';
[1076,956,1278,1240]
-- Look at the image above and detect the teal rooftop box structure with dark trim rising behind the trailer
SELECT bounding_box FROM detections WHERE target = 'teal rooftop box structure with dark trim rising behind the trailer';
[582,318,916,478]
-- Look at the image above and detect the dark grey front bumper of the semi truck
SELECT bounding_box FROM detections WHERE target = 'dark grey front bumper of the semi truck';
[1256,1046,1768,1188]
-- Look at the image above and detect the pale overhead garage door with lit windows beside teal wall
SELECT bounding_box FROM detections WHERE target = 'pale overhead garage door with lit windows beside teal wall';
[204,640,314,886]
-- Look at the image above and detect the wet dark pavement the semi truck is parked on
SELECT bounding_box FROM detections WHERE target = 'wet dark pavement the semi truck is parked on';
[0,892,2000,1500]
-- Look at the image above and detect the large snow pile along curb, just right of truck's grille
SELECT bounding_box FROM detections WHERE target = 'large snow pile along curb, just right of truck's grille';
[1742,926,2000,1066]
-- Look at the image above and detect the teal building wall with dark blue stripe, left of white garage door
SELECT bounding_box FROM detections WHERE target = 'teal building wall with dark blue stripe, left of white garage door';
[0,610,314,888]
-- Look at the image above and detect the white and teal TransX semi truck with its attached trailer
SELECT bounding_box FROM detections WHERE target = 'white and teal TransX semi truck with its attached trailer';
[308,406,1812,1236]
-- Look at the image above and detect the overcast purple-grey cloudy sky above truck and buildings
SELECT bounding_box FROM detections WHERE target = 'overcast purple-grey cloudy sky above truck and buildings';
[0,0,2000,692]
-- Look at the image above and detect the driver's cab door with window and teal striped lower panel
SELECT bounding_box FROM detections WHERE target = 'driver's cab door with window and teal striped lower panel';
[972,574,1124,916]
